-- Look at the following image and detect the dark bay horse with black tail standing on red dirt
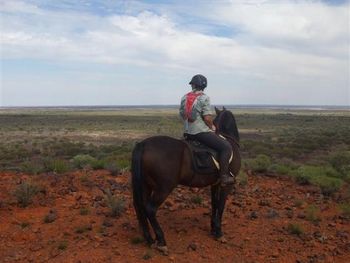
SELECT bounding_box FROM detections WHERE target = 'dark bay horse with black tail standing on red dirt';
[131,107,241,254]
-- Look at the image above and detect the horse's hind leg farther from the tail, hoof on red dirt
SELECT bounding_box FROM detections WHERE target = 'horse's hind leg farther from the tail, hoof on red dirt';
[146,191,171,252]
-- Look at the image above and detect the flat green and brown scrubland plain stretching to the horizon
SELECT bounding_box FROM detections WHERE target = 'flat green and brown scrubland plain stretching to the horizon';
[0,109,350,196]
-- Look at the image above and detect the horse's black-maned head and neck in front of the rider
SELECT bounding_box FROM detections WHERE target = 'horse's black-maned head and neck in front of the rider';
[214,107,239,142]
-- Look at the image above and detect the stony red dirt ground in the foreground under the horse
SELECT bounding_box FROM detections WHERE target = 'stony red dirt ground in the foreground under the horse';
[0,171,350,263]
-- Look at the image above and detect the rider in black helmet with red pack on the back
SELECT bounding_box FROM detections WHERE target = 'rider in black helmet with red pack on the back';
[179,74,234,186]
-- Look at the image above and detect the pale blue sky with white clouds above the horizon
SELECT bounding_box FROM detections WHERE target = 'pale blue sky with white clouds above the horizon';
[0,0,350,107]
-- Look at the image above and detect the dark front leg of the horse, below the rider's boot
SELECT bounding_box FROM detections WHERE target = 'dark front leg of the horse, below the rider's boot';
[211,185,231,239]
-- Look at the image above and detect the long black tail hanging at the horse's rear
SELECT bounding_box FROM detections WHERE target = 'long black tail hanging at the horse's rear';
[131,143,147,229]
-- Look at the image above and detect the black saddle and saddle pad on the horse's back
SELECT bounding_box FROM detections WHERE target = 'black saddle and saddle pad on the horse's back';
[183,139,232,174]
